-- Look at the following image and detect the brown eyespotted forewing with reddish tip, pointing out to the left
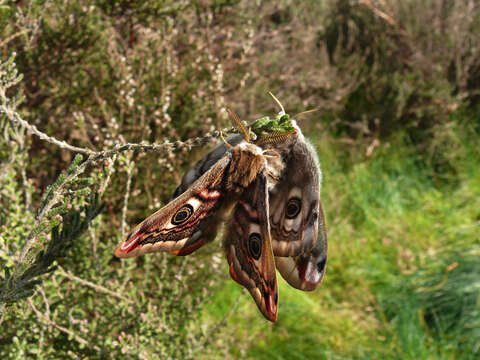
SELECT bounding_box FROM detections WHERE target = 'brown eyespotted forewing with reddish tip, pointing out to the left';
[115,152,231,258]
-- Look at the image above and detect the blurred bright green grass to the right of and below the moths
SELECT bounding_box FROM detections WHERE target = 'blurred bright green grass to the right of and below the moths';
[202,115,480,359]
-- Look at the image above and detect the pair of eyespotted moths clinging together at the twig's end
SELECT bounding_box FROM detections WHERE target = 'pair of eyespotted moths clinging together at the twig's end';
[115,94,327,322]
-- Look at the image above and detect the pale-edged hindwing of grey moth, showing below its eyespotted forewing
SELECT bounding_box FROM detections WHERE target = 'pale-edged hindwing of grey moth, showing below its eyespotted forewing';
[275,204,328,291]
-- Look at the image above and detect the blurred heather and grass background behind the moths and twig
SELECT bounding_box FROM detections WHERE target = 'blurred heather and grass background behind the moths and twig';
[0,0,480,359]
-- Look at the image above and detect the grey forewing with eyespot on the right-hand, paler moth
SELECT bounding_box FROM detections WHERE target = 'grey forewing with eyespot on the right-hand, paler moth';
[270,135,321,256]
